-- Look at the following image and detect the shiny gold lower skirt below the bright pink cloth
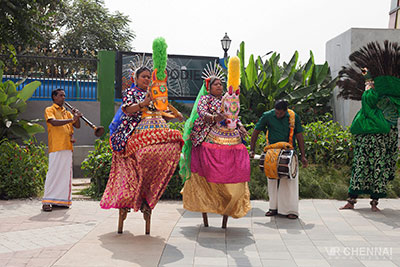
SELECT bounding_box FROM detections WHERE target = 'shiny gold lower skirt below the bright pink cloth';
[181,173,251,218]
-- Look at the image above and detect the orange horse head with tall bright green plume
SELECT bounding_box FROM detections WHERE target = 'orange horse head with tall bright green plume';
[150,37,168,111]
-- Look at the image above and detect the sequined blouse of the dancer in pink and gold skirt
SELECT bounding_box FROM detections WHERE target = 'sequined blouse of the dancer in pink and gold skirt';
[190,94,222,146]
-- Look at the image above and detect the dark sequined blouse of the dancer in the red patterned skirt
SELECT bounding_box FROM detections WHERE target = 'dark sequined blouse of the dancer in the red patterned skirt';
[110,87,147,151]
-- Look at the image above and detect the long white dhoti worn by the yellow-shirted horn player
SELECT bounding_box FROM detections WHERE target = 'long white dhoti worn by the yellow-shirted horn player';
[42,150,72,207]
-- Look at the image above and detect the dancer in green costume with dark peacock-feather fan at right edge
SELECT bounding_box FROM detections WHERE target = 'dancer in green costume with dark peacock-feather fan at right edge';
[338,41,400,214]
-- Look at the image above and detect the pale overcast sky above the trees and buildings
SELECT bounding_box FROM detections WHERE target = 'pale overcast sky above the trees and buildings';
[105,0,391,64]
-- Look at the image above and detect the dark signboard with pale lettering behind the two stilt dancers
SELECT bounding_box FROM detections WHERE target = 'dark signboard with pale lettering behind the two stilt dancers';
[116,52,219,100]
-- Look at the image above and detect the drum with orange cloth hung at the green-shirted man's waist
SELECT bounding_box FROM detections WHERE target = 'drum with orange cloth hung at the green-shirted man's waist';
[259,149,298,179]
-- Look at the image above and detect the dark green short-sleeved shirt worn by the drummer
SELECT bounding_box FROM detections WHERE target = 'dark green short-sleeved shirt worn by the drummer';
[255,109,304,147]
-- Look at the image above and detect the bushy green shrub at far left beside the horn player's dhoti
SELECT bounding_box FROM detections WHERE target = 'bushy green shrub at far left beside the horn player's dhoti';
[0,138,48,199]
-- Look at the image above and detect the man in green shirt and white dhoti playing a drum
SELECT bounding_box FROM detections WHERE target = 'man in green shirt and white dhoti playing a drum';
[250,100,307,219]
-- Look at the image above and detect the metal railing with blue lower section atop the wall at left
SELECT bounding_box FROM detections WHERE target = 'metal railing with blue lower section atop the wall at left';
[0,51,98,101]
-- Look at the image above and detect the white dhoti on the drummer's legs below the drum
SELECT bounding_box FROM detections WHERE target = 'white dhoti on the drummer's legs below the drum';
[268,172,299,216]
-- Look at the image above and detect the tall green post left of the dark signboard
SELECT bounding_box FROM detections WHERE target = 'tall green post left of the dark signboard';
[97,51,116,132]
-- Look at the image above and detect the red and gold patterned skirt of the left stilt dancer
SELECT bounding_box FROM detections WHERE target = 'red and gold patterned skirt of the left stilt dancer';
[100,126,183,211]
